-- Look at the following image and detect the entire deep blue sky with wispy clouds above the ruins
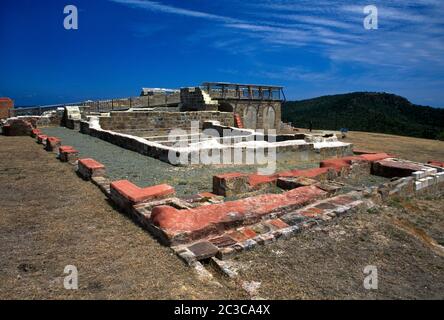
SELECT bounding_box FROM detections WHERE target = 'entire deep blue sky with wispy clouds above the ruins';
[0,0,444,107]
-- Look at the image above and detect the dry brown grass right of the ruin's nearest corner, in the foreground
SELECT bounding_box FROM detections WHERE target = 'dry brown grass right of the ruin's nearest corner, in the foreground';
[237,198,444,299]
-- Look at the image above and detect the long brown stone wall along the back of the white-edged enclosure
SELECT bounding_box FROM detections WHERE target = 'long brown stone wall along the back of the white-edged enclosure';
[100,111,234,135]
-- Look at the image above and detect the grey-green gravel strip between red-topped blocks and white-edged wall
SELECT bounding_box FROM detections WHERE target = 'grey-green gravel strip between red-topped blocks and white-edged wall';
[42,127,319,196]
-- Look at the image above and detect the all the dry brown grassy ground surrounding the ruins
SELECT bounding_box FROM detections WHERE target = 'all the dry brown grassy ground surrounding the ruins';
[0,133,444,299]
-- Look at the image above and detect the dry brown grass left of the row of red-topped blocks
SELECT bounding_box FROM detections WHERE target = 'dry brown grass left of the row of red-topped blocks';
[0,136,242,299]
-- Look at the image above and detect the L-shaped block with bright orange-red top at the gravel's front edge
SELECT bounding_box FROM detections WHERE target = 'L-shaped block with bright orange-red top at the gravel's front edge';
[111,180,175,205]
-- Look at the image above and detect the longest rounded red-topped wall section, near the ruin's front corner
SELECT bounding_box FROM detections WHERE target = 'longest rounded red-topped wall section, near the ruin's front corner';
[151,186,327,244]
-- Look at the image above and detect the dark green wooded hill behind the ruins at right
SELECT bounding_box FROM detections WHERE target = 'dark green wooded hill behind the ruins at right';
[282,92,444,140]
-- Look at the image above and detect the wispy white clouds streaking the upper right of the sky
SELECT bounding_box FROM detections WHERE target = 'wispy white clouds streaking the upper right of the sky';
[110,0,444,88]
